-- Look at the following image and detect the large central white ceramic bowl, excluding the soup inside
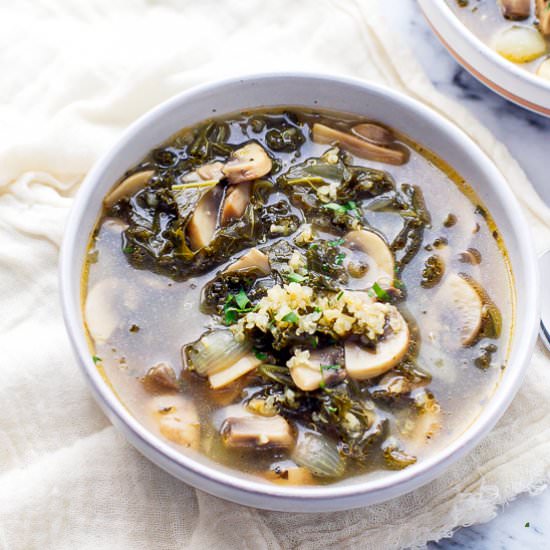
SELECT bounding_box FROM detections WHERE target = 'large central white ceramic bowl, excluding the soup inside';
[60,74,538,512]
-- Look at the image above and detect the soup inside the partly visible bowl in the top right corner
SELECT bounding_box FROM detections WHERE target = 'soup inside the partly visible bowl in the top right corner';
[447,0,550,80]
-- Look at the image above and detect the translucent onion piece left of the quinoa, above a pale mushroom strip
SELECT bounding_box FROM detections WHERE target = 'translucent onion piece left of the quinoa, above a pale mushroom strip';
[187,330,252,376]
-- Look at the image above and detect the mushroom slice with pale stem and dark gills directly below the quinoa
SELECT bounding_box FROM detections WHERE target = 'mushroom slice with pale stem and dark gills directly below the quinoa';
[287,348,344,391]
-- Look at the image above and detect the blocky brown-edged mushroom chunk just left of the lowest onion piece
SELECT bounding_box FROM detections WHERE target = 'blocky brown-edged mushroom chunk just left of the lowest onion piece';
[221,415,294,449]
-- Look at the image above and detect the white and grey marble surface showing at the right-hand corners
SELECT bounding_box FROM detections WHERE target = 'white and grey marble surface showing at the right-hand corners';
[386,0,550,550]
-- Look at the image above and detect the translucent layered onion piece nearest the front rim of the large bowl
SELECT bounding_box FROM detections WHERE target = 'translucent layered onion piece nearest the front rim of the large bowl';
[291,432,346,478]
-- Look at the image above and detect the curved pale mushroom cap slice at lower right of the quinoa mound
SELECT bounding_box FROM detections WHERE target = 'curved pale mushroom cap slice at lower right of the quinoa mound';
[344,309,410,380]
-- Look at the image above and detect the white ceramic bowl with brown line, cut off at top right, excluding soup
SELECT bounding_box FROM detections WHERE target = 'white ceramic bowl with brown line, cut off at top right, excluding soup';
[418,0,550,116]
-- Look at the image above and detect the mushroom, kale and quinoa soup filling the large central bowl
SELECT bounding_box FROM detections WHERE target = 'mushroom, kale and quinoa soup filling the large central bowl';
[83,108,513,485]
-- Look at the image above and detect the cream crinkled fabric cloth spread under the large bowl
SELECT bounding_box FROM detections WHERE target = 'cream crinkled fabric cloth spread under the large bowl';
[0,0,550,550]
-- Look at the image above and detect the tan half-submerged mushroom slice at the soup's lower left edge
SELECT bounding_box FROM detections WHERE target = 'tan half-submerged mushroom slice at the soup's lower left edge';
[149,394,200,449]
